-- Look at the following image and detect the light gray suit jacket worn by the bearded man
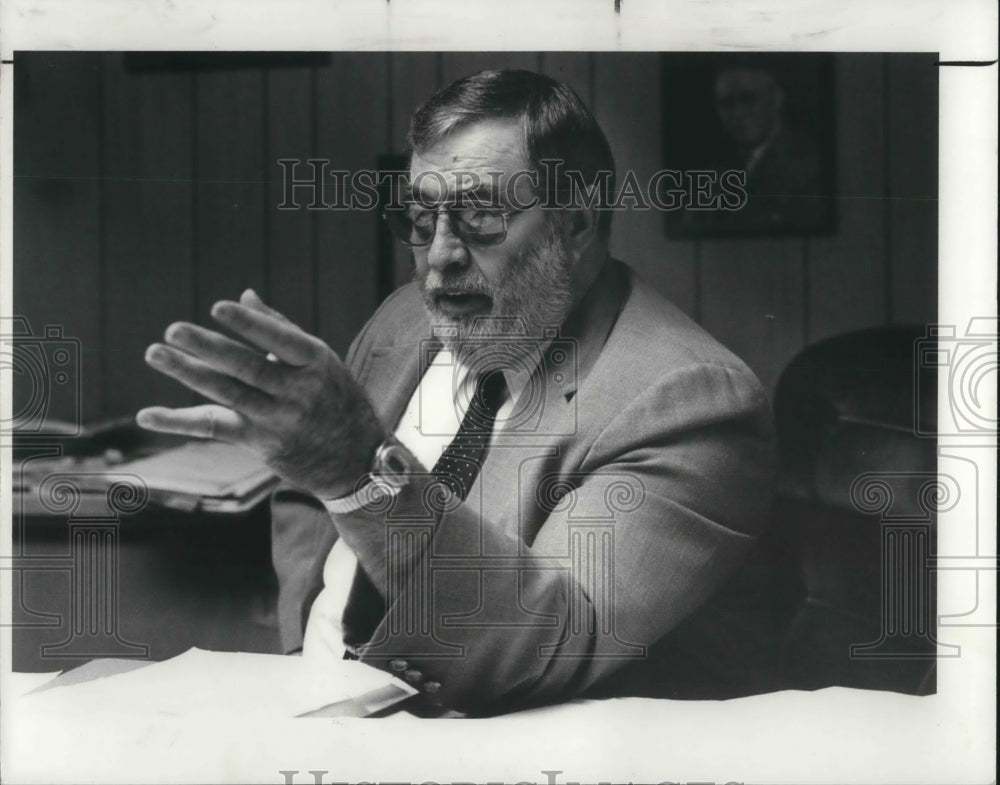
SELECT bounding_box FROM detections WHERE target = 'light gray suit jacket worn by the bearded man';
[272,262,773,712]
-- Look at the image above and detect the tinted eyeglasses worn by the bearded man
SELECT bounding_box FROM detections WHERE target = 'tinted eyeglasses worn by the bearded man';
[382,202,521,248]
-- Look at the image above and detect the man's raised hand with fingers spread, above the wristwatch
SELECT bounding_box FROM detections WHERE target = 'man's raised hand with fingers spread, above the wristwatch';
[136,289,388,498]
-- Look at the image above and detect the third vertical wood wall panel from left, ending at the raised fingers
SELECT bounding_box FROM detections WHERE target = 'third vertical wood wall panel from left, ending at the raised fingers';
[195,68,267,323]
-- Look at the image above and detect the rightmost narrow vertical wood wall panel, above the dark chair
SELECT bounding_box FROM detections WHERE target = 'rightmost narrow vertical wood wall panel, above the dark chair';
[886,54,938,324]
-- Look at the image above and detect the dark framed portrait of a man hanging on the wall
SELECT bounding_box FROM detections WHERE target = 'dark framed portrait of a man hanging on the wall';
[659,53,836,238]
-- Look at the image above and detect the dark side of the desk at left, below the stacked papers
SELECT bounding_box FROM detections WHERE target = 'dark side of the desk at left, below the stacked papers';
[11,503,279,672]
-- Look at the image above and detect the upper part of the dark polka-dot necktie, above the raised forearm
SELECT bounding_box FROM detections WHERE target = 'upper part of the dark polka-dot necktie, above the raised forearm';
[432,370,507,500]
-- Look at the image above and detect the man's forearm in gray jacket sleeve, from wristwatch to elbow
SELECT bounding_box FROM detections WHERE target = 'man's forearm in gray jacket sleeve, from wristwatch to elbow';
[336,468,595,711]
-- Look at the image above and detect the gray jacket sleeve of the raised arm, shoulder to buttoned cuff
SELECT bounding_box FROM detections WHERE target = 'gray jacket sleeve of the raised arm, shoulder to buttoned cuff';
[333,365,773,713]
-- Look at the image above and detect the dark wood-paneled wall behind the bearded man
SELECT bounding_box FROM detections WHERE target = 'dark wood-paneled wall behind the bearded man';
[14,52,937,420]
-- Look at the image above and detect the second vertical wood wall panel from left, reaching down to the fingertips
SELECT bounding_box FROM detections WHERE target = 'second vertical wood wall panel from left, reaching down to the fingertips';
[104,54,194,415]
